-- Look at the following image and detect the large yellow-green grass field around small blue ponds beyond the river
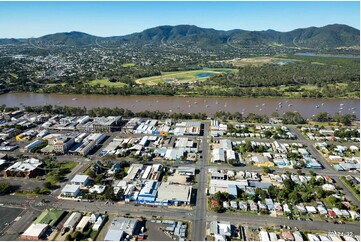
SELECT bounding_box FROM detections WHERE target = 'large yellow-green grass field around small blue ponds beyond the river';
[135,68,235,86]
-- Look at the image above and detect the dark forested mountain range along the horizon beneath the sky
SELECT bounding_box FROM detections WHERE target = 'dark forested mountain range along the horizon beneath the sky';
[0,24,360,49]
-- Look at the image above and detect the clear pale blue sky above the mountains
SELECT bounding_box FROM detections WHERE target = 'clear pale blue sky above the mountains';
[0,1,360,38]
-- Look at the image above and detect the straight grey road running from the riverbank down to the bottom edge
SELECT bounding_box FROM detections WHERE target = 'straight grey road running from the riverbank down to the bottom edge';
[191,122,209,241]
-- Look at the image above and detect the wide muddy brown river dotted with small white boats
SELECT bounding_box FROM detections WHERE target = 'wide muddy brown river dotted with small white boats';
[0,93,360,119]
